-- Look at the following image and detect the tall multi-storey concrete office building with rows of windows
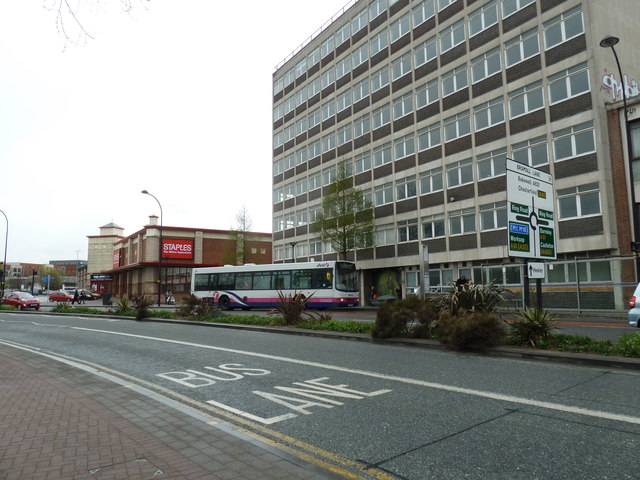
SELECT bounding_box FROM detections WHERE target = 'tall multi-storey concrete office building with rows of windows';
[273,0,640,308]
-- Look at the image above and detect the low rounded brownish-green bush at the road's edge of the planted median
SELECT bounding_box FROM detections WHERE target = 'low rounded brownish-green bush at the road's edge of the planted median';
[437,310,505,347]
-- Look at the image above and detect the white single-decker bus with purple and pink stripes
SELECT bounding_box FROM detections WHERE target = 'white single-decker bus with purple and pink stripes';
[191,261,359,310]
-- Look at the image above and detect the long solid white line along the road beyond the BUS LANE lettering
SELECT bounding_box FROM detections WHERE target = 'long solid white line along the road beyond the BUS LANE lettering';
[71,327,640,425]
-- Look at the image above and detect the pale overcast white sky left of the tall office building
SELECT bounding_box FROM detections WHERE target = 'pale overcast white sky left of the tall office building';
[0,0,352,264]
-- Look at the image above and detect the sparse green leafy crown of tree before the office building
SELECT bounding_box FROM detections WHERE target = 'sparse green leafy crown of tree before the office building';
[311,162,374,259]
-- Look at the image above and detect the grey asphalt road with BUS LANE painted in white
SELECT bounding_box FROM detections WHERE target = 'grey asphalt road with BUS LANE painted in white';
[0,311,640,480]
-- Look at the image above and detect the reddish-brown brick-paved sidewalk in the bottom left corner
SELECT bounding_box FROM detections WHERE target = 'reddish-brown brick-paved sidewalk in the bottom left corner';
[0,345,338,480]
